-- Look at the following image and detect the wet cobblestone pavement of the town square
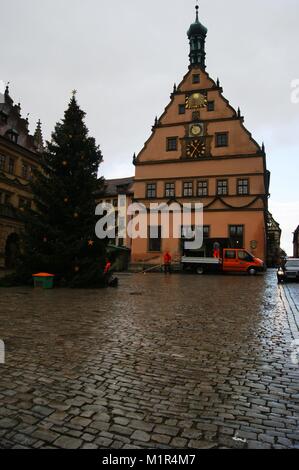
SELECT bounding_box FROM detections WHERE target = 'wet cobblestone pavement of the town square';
[0,271,299,449]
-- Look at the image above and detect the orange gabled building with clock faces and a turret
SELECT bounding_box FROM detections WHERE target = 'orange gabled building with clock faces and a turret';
[132,6,270,264]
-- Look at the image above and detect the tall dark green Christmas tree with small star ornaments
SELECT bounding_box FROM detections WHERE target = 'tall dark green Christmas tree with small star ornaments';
[2,92,106,287]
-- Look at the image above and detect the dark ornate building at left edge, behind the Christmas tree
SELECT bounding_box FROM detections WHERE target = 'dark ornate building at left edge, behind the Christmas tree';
[0,86,43,268]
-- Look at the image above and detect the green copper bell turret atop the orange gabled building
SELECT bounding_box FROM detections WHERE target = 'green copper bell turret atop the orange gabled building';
[187,0,208,69]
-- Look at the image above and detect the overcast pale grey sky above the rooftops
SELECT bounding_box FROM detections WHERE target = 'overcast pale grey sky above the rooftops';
[0,0,299,253]
